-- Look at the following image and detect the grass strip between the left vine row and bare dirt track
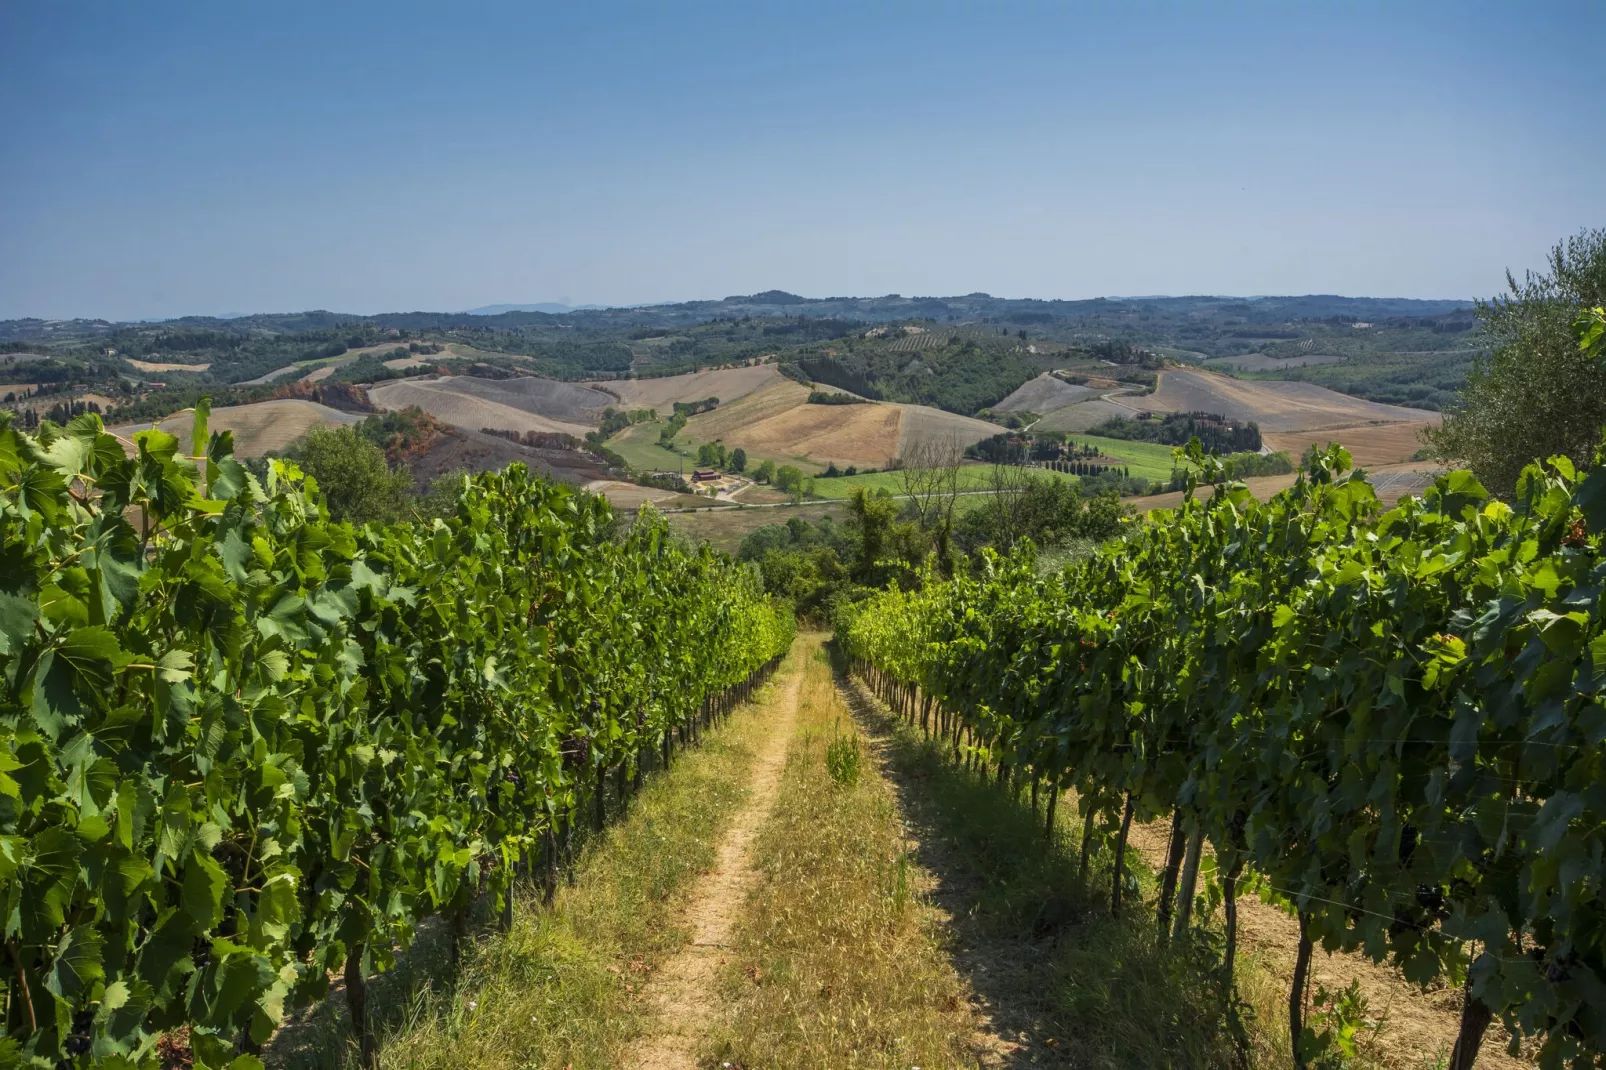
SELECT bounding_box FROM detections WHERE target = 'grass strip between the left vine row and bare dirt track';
[358,658,796,1070]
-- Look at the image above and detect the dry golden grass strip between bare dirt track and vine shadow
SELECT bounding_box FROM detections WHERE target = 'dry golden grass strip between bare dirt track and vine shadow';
[711,639,978,1068]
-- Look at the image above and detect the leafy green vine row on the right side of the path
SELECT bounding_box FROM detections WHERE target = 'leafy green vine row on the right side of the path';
[838,436,1606,1070]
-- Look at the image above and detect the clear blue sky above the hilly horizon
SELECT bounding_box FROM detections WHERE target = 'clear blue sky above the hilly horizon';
[0,0,1606,318]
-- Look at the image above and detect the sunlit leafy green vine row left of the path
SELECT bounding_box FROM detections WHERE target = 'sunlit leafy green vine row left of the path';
[0,405,793,1070]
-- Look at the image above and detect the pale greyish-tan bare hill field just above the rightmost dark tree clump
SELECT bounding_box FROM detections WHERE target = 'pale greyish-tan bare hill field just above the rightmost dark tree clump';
[1132,368,1439,431]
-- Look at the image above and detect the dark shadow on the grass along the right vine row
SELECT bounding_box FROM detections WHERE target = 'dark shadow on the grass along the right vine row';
[837,642,1248,1070]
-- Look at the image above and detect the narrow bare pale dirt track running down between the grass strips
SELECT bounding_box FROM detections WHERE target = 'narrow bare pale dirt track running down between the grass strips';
[623,639,808,1070]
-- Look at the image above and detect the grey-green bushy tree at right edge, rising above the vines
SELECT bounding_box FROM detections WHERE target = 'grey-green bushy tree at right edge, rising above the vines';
[1428,230,1606,495]
